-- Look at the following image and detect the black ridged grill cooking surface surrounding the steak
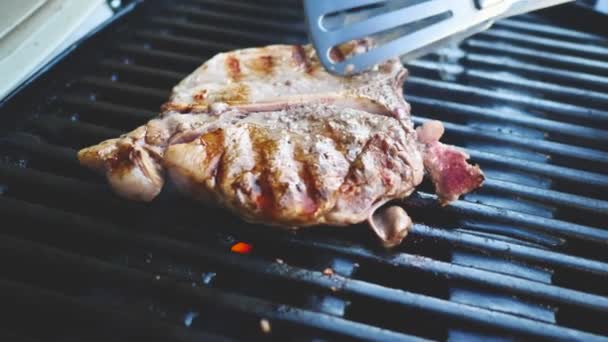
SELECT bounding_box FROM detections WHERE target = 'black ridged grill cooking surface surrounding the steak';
[0,0,608,341]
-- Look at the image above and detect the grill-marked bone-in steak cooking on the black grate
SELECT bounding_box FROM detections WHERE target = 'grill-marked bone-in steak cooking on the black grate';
[78,41,483,246]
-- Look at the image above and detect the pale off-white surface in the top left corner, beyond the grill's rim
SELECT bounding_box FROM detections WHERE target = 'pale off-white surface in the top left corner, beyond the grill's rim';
[0,0,112,98]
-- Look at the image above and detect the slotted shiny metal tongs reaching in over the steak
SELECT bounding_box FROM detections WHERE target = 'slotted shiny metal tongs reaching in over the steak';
[304,0,572,75]
